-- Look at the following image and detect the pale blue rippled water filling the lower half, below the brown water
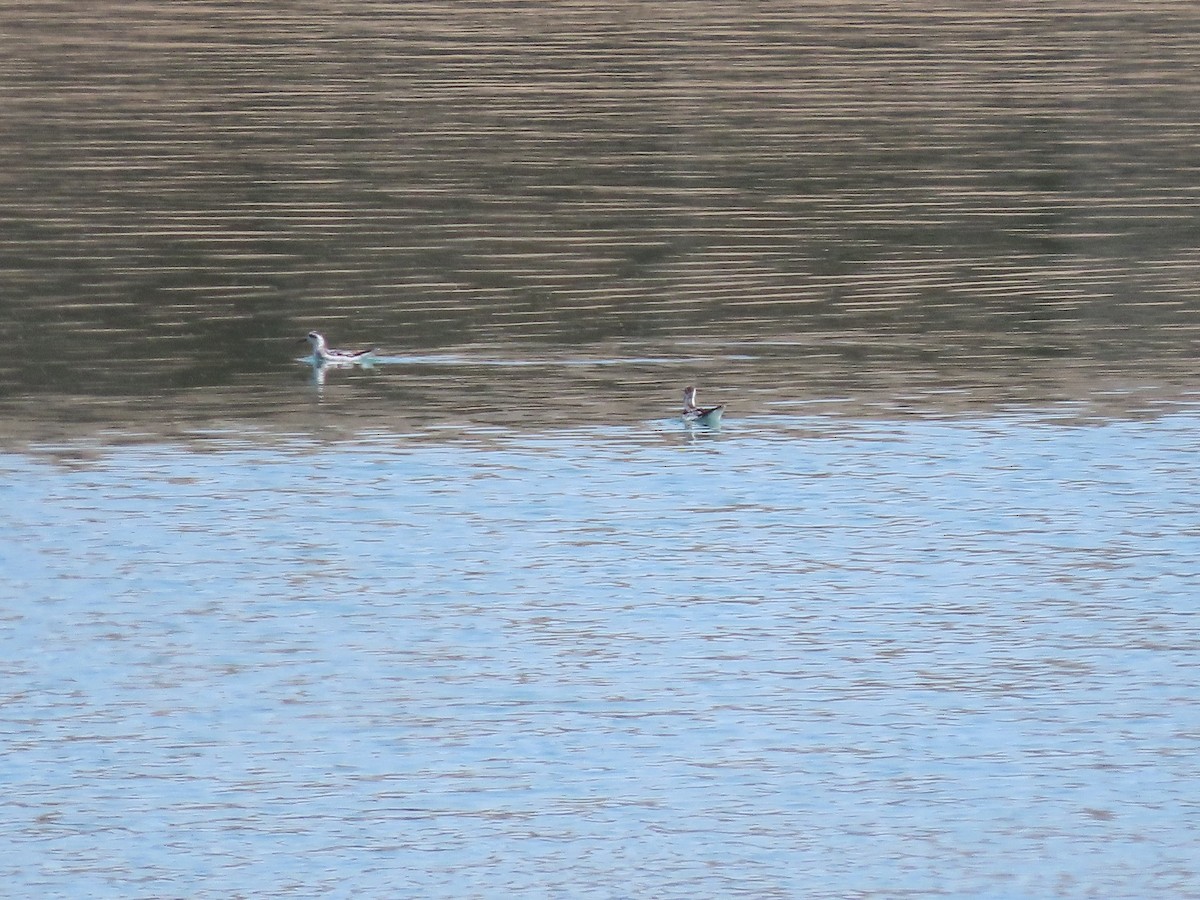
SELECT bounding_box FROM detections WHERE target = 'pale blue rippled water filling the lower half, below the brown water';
[0,404,1200,898]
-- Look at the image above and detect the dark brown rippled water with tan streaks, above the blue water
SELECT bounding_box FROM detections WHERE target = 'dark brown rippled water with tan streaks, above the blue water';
[0,2,1200,448]
